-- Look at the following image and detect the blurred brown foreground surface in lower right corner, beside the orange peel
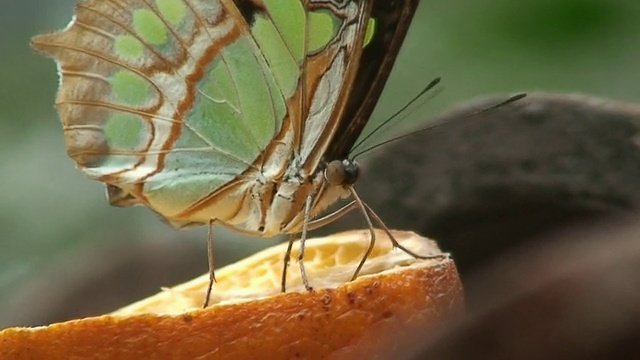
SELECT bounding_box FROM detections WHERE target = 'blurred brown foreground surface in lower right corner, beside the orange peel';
[406,216,640,360]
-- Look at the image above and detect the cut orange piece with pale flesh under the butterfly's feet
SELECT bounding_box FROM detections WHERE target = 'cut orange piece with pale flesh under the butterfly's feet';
[0,231,463,359]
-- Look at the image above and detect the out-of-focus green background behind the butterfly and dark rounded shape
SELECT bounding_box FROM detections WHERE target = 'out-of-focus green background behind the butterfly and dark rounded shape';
[0,0,640,328]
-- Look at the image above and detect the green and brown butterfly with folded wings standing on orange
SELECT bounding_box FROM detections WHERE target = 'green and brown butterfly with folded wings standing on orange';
[32,0,419,306]
